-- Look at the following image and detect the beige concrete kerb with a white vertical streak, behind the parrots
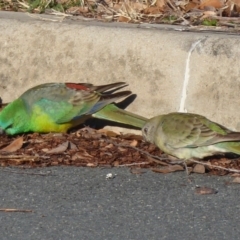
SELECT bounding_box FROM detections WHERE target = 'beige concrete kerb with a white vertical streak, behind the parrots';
[0,12,240,130]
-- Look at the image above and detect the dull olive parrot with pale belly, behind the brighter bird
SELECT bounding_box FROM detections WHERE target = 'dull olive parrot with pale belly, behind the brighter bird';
[142,113,240,160]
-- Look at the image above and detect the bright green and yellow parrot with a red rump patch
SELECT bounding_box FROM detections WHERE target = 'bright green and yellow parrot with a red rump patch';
[0,82,147,135]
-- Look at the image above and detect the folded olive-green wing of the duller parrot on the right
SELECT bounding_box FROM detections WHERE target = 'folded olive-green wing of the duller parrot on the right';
[162,113,240,148]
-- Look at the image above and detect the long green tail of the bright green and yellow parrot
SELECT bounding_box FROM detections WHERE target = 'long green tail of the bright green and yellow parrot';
[92,104,148,128]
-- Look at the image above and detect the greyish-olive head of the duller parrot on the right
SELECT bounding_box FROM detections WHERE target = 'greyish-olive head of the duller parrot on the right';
[142,118,158,143]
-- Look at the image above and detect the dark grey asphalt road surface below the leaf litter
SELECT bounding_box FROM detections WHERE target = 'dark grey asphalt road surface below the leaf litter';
[0,167,240,240]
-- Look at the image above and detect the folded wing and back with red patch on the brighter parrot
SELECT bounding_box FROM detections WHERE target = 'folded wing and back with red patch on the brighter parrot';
[20,82,131,124]
